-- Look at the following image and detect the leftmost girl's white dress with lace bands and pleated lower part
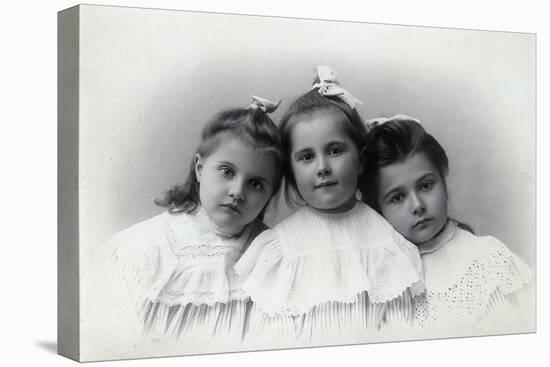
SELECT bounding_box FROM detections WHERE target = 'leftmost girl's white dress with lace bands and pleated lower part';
[110,209,265,345]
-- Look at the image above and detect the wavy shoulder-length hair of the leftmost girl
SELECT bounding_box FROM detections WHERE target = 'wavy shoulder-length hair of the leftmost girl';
[155,107,284,220]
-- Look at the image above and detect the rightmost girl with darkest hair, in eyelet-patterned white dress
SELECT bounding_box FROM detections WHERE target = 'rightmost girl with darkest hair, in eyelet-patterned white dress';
[363,115,531,337]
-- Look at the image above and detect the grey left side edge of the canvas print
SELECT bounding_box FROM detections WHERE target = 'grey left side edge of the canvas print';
[57,6,80,361]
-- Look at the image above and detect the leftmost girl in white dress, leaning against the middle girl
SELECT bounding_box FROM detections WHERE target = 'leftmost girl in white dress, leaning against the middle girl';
[108,96,284,353]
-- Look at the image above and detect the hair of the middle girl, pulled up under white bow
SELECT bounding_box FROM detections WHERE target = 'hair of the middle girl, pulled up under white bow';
[279,87,367,206]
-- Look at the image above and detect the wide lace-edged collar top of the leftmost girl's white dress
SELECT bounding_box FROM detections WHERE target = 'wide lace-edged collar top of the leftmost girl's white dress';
[111,212,263,306]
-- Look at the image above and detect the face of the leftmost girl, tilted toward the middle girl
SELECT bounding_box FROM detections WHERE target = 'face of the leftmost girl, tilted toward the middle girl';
[195,136,276,233]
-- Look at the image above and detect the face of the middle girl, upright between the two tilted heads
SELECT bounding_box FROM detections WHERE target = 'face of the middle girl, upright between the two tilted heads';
[290,110,361,212]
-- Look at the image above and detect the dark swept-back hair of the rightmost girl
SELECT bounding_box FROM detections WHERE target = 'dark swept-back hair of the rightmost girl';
[363,117,449,212]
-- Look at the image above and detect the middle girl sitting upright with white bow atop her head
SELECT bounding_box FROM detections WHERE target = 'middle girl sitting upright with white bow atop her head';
[235,66,423,345]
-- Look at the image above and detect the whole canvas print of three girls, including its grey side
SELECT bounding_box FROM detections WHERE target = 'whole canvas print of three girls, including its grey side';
[58,5,536,361]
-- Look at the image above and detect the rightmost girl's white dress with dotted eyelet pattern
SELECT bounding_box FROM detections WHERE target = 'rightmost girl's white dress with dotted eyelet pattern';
[390,221,532,337]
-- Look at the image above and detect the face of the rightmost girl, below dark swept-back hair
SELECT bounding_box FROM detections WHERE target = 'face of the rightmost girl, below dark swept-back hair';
[378,153,447,244]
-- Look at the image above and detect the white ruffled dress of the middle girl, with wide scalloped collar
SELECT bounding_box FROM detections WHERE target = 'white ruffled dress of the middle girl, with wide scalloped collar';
[235,202,424,347]
